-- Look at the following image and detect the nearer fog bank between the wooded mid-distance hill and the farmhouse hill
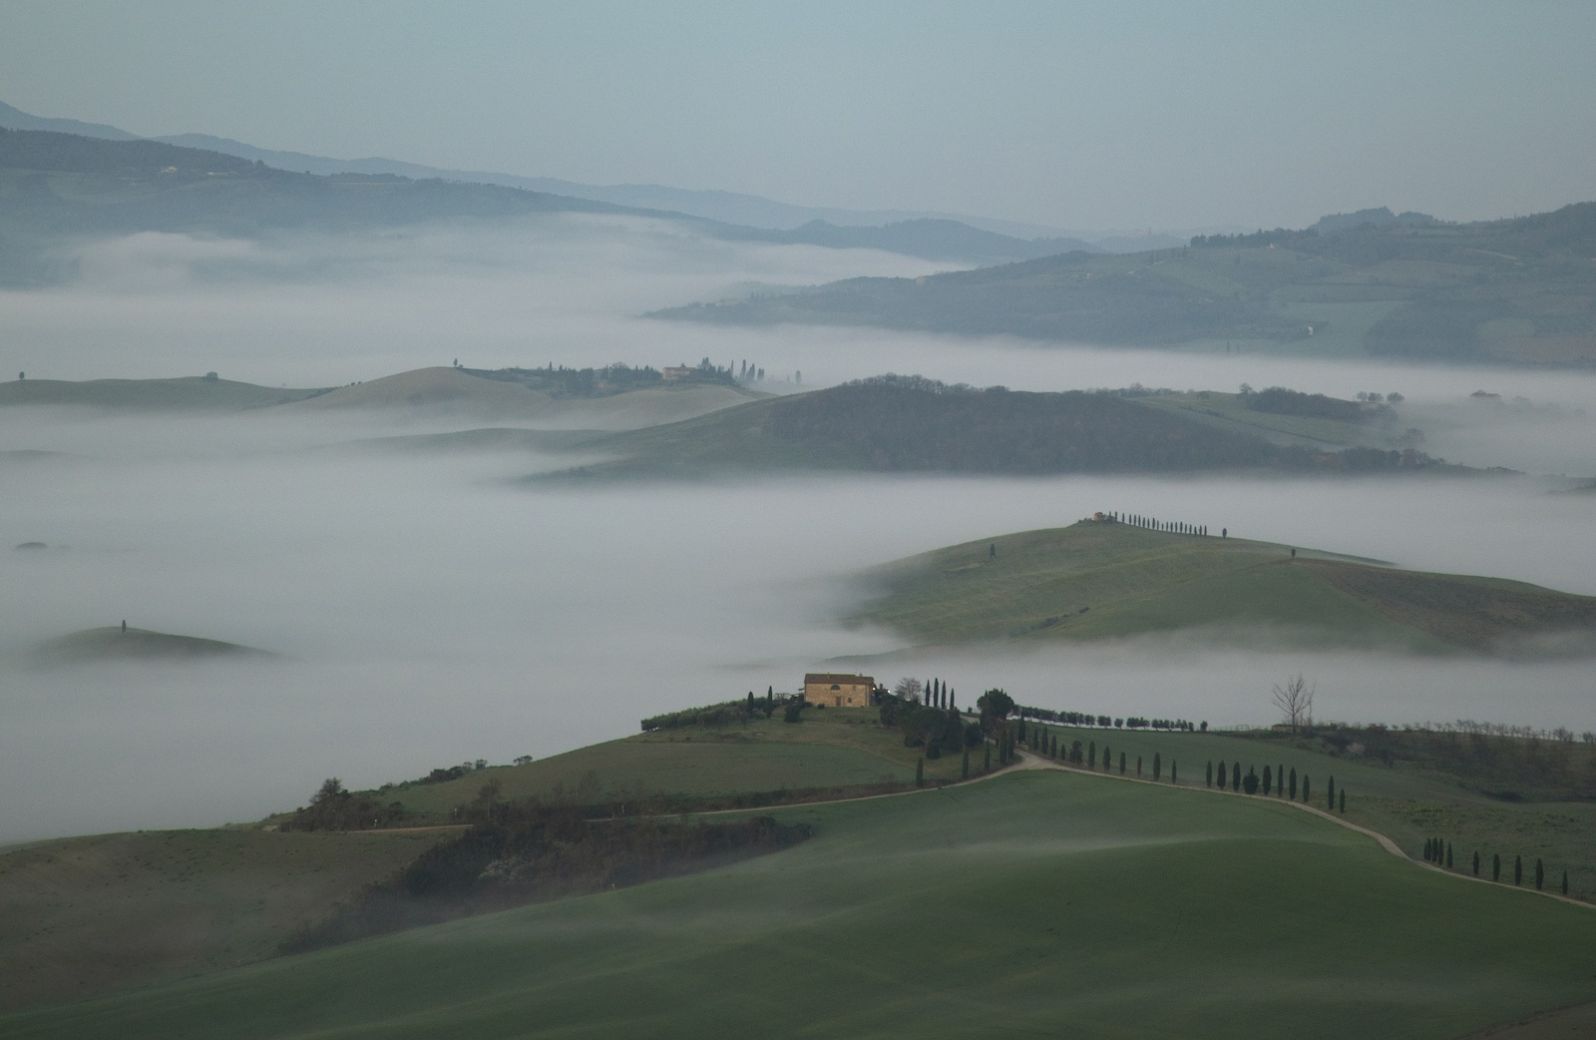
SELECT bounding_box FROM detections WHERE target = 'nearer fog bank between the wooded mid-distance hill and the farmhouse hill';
[0,420,1596,839]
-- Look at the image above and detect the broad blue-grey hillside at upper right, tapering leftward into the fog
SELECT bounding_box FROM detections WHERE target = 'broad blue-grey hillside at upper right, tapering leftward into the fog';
[656,203,1596,365]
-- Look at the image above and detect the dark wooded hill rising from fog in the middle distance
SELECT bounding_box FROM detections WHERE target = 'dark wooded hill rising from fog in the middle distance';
[549,376,1456,477]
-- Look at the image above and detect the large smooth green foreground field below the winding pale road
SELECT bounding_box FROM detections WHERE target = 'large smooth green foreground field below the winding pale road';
[12,774,1596,1040]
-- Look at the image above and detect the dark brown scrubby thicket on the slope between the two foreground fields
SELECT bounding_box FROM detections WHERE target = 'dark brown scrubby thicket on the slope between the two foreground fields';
[284,799,811,952]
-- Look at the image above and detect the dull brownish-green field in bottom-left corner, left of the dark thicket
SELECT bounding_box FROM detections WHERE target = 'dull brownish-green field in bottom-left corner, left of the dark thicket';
[0,831,450,1010]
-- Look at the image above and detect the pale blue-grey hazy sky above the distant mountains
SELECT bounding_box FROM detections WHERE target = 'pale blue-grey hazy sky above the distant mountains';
[0,0,1596,230]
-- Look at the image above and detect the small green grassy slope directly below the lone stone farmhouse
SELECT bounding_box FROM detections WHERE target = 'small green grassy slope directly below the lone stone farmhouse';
[373,708,980,820]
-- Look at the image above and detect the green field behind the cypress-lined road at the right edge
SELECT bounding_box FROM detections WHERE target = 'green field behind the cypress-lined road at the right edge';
[1021,726,1596,900]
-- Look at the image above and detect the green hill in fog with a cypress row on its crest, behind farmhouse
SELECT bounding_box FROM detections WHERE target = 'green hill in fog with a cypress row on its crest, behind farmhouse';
[851,520,1596,652]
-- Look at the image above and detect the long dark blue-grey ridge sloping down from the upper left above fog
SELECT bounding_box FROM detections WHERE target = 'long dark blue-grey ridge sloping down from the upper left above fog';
[0,128,1090,277]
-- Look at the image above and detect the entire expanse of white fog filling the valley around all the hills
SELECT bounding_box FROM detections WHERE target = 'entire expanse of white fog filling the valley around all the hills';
[0,217,1596,842]
